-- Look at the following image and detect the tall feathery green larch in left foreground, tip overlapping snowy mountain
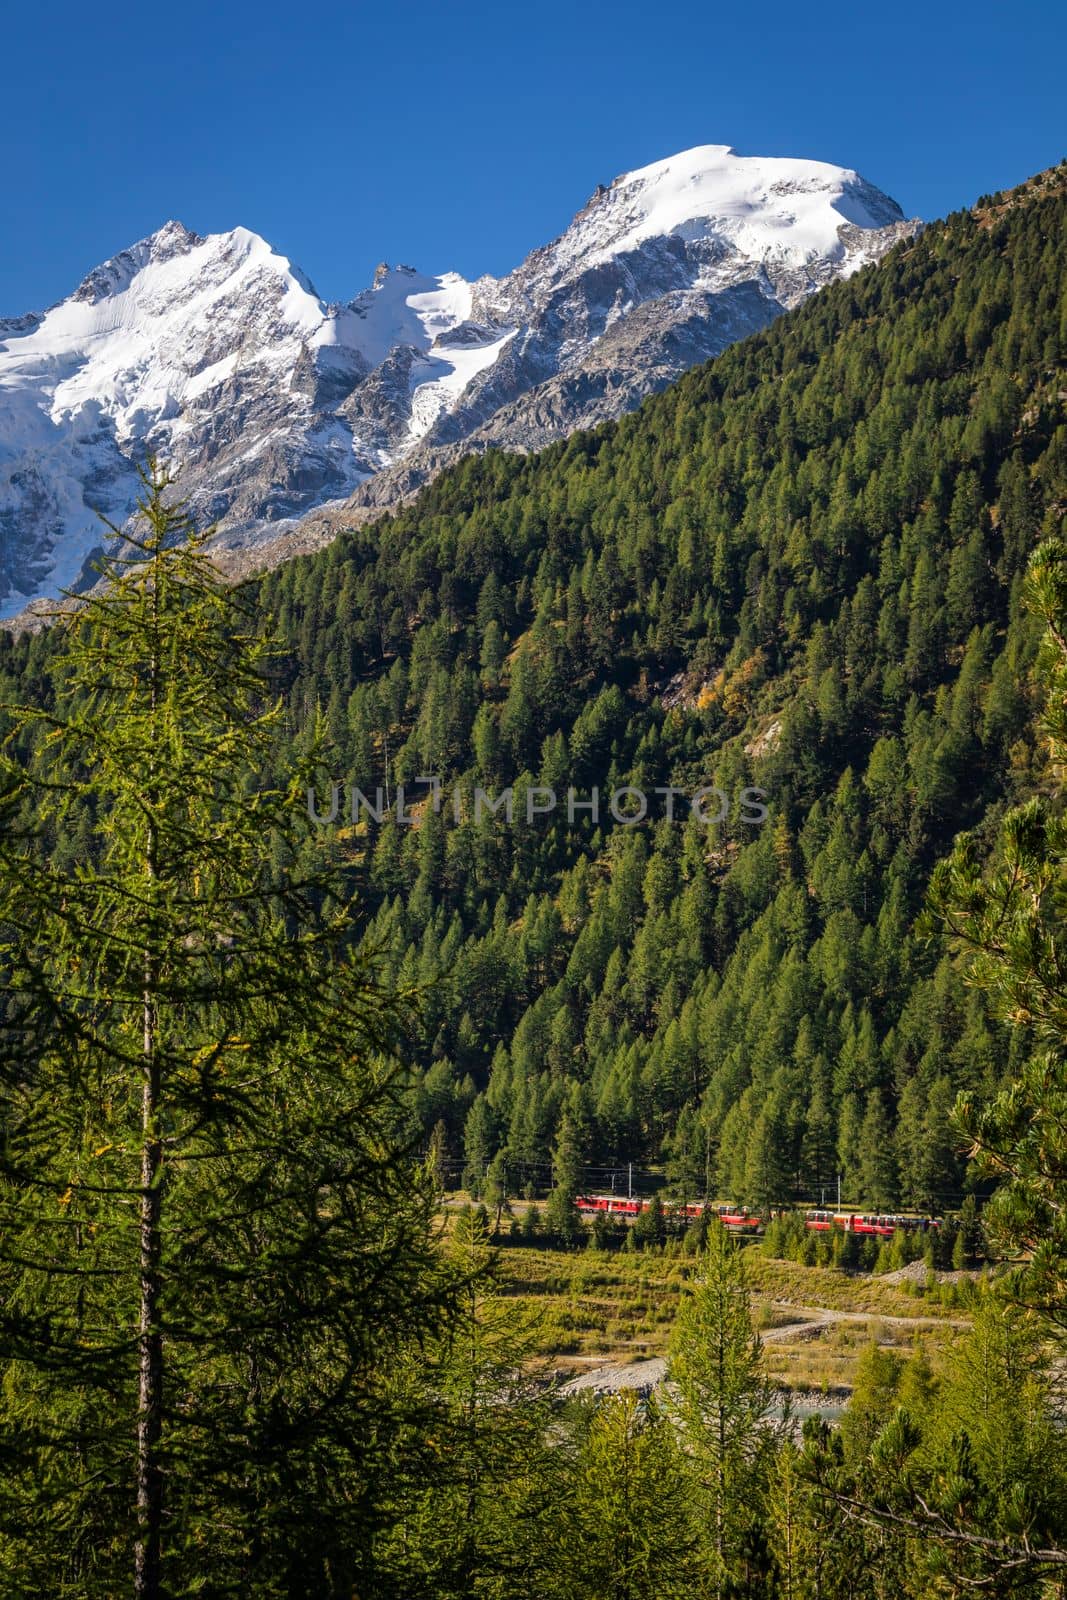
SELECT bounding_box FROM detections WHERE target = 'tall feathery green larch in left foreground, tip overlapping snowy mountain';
[0,467,445,1600]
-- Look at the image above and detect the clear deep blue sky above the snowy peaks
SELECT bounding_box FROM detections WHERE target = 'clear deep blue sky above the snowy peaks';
[0,0,1067,315]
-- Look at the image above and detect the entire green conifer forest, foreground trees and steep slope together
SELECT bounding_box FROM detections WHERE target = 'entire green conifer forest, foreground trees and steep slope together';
[0,166,1067,1600]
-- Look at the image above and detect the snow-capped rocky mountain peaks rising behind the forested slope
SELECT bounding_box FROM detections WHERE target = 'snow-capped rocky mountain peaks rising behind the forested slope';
[0,146,918,618]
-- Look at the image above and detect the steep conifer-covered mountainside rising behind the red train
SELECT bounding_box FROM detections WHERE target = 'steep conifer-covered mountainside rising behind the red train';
[239,170,1067,1210]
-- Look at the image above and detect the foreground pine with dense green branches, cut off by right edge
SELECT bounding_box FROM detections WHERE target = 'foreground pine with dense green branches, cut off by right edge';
[808,541,1067,1597]
